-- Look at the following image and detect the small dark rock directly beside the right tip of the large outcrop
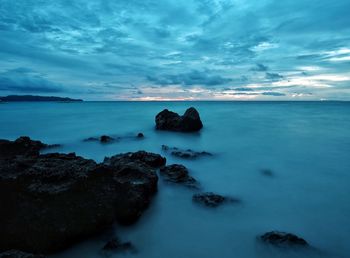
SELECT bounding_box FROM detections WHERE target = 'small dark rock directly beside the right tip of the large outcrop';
[160,164,198,188]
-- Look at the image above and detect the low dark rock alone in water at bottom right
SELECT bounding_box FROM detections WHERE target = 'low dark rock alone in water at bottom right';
[260,231,309,247]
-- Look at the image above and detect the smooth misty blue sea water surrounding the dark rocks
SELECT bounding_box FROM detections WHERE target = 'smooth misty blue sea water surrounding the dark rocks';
[0,102,350,258]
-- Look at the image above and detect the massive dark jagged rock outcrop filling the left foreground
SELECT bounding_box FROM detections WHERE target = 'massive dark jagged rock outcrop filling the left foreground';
[0,138,165,254]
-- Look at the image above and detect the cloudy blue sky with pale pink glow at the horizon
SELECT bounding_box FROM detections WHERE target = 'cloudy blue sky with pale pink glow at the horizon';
[0,0,350,101]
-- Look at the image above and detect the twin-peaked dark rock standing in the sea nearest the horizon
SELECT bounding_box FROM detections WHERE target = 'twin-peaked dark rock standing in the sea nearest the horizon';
[156,107,203,132]
